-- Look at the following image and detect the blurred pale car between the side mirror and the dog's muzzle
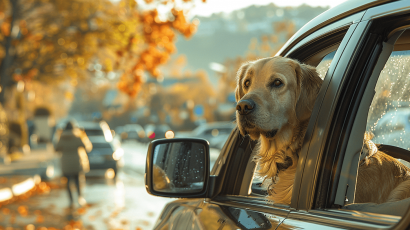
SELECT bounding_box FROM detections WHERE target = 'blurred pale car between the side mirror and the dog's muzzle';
[176,122,235,149]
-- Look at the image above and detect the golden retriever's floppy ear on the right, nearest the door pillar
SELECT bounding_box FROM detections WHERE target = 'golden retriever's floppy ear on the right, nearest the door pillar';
[292,61,323,121]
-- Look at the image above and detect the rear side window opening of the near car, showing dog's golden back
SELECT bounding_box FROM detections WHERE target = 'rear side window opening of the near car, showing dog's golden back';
[335,27,410,218]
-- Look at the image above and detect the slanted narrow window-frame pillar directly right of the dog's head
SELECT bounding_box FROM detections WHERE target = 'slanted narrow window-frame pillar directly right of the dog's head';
[291,22,363,210]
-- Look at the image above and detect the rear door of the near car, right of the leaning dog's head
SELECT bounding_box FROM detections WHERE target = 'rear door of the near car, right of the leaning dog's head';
[280,1,410,229]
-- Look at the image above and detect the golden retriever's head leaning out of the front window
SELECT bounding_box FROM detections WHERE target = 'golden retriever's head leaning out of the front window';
[235,57,322,141]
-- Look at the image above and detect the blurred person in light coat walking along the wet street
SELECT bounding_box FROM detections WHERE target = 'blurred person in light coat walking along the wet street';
[55,122,92,208]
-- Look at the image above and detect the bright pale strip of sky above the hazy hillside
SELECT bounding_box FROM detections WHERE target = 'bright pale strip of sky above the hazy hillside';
[190,0,346,16]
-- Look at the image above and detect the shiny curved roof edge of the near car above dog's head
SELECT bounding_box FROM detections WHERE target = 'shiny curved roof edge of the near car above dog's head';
[276,0,394,56]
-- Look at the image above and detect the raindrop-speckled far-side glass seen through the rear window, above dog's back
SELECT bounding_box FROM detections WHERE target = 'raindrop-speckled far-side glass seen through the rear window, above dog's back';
[366,50,410,150]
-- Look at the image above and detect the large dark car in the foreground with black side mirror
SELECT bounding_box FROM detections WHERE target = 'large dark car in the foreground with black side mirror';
[145,0,410,229]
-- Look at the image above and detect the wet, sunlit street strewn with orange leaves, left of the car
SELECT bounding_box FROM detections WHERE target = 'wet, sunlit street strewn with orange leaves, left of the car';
[0,142,172,230]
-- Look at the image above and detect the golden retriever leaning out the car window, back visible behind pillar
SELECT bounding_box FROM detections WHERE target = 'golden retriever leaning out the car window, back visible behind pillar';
[235,57,410,204]
